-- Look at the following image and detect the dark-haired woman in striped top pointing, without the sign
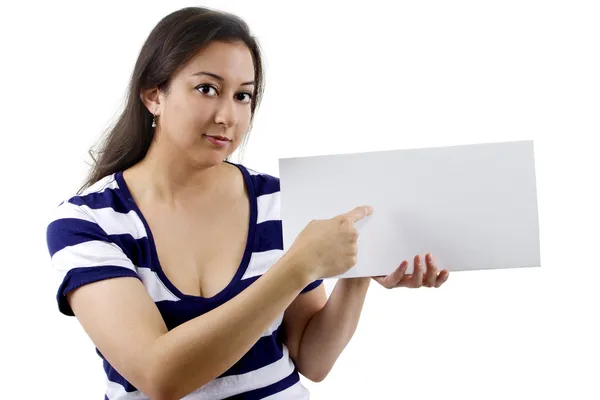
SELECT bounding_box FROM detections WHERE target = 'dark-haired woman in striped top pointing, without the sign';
[47,8,448,400]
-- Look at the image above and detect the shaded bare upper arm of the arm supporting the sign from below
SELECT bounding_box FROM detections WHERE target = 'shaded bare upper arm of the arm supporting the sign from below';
[283,281,327,362]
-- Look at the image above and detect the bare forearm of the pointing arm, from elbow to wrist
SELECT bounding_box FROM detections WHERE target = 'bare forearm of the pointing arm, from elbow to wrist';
[152,256,311,399]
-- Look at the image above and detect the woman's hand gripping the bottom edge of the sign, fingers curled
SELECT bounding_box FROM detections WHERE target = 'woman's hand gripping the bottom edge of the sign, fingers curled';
[373,253,450,289]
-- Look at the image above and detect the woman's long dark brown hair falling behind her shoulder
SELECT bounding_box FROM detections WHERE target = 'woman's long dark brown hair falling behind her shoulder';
[80,7,264,191]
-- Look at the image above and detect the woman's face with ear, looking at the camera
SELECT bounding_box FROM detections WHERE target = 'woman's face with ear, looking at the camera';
[150,42,255,166]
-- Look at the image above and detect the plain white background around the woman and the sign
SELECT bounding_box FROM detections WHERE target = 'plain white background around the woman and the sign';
[0,0,600,400]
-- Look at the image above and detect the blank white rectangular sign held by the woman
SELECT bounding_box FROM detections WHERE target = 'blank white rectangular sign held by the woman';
[279,141,540,278]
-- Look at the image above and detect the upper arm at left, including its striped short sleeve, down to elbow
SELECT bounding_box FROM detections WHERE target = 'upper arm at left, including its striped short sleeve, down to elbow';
[47,203,167,394]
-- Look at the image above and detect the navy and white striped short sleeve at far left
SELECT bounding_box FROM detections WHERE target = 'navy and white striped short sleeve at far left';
[46,202,139,316]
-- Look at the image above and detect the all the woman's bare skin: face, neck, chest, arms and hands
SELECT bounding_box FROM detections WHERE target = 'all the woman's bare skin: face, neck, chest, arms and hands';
[67,42,448,399]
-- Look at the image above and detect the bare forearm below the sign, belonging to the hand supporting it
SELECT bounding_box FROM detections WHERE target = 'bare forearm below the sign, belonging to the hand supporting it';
[298,278,370,381]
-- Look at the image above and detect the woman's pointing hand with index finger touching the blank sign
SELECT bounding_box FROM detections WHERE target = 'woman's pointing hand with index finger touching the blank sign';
[289,206,373,279]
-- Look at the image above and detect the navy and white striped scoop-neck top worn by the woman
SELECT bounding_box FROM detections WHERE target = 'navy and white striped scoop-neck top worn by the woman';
[47,163,322,400]
